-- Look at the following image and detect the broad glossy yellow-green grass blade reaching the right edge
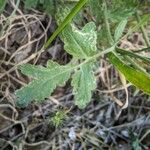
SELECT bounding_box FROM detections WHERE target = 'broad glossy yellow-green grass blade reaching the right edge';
[108,53,150,94]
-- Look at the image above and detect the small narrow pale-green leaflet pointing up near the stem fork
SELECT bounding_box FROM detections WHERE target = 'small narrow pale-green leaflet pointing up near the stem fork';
[114,19,127,42]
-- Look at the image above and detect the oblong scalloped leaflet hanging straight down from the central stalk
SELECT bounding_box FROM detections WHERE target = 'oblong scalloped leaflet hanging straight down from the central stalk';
[72,63,96,108]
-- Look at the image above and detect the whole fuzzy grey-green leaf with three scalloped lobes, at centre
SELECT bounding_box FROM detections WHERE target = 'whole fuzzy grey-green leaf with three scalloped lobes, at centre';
[16,20,97,108]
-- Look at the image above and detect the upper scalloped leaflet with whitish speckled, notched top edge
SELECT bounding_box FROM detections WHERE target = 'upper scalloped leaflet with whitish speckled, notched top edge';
[61,22,97,59]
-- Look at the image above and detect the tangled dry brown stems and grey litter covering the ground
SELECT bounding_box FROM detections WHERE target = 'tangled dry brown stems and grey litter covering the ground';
[0,0,150,150]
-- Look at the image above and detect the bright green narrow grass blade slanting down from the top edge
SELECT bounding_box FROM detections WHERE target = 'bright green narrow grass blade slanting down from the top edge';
[44,0,88,49]
